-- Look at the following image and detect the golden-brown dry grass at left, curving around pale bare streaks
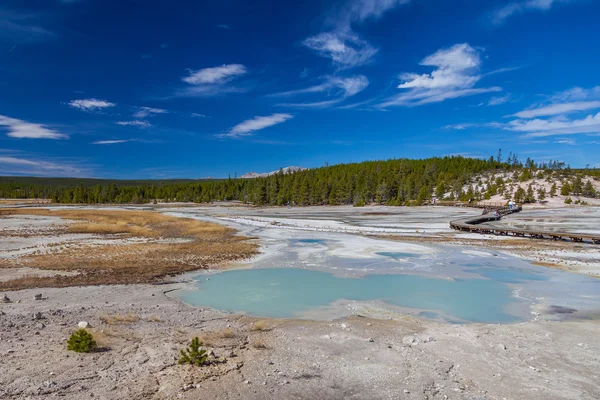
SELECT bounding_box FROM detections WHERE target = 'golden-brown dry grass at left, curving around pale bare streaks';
[0,208,258,290]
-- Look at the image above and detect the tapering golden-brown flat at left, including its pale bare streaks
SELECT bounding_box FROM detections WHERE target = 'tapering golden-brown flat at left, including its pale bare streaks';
[0,208,258,290]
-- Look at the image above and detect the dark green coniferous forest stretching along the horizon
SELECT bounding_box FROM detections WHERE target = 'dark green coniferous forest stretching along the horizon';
[0,151,600,206]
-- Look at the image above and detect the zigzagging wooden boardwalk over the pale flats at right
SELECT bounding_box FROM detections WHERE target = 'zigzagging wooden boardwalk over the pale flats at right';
[450,206,600,244]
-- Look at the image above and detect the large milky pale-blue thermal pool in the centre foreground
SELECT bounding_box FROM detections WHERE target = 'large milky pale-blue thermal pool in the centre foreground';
[177,268,520,323]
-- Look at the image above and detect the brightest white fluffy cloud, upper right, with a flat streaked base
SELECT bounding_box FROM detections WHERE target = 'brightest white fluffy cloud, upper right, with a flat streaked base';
[380,43,502,108]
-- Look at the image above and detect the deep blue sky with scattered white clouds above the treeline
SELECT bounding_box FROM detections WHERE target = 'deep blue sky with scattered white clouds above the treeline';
[0,0,600,179]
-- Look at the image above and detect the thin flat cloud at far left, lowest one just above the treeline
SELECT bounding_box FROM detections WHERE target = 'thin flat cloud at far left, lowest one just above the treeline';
[0,156,83,176]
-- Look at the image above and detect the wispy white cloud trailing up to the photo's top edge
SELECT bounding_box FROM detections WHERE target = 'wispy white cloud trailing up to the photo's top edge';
[302,0,409,70]
